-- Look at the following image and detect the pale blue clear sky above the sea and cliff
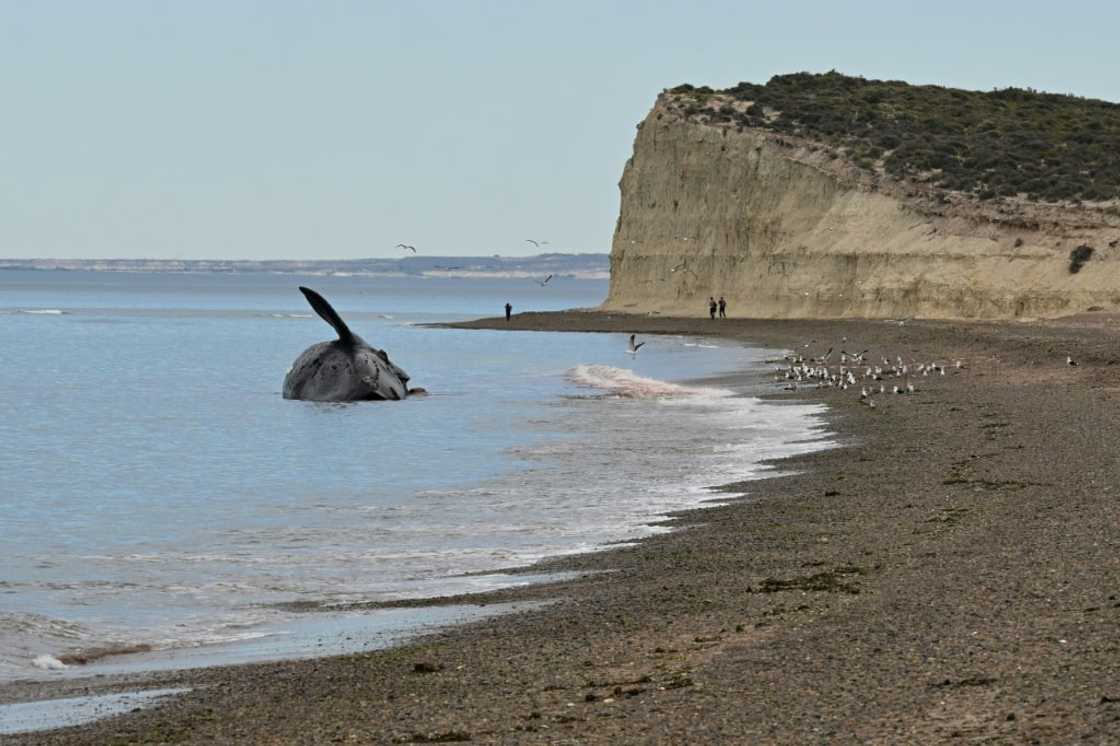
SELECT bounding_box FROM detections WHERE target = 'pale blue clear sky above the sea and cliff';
[0,0,1120,259]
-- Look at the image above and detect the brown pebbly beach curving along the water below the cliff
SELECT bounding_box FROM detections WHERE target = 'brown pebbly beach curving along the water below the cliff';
[4,306,1120,744]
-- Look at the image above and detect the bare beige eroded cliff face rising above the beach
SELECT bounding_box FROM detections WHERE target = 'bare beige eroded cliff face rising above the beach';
[603,94,1120,319]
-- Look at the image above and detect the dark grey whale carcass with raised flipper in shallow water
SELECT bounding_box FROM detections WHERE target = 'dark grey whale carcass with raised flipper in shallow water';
[283,287,409,401]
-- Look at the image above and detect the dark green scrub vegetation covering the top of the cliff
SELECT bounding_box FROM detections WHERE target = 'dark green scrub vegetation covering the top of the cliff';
[671,71,1120,202]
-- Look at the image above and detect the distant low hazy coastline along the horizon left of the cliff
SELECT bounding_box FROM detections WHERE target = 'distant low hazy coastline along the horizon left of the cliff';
[0,253,610,280]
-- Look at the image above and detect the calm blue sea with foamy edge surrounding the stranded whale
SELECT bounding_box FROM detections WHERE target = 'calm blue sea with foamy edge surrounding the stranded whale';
[0,271,831,680]
